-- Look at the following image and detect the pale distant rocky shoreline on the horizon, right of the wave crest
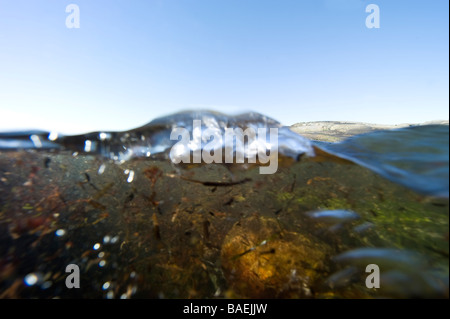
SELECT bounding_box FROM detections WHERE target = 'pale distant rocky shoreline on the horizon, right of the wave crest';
[290,120,449,142]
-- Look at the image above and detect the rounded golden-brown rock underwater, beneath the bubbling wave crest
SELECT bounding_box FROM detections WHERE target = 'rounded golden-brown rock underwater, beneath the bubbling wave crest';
[221,216,329,298]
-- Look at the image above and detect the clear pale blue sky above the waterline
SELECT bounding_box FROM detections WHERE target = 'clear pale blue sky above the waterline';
[0,0,449,134]
